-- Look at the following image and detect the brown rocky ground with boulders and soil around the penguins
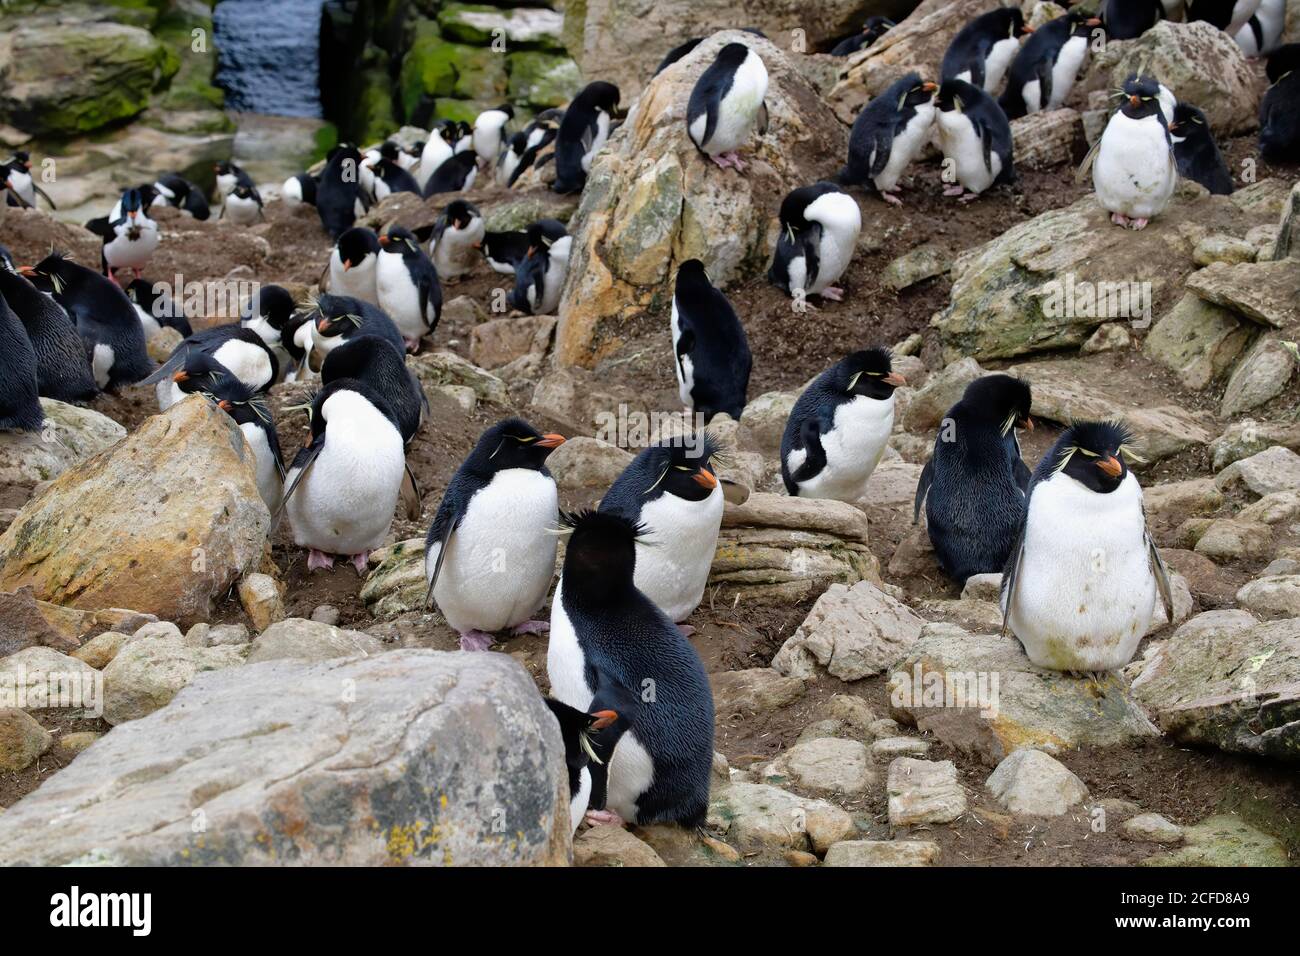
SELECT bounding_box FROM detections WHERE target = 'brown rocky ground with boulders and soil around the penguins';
[0,3,1300,866]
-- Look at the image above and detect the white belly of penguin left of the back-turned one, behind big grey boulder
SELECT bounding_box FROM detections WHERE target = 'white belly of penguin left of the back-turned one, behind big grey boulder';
[425,468,556,634]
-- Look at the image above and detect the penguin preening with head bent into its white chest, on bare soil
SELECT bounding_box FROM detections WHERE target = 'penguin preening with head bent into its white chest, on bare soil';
[767,182,862,302]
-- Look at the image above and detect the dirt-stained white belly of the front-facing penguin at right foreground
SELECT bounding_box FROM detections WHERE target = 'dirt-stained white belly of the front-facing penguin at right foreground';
[1004,473,1156,671]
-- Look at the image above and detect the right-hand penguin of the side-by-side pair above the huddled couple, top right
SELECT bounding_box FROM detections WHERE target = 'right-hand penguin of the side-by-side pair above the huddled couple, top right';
[998,10,1101,120]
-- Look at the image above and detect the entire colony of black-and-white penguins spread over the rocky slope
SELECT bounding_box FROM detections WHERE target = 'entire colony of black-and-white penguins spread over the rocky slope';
[0,0,1300,829]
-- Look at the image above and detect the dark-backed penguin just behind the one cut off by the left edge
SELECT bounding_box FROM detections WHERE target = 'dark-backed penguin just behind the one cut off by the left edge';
[0,265,99,402]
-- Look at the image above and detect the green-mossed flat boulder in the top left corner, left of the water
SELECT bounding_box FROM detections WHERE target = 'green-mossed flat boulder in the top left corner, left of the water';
[0,22,179,135]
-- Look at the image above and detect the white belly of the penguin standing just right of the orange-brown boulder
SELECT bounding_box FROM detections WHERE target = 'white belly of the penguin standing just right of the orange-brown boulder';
[285,412,404,554]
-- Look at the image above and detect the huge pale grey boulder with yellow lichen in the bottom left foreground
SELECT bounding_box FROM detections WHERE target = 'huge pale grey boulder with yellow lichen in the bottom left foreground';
[0,650,574,866]
